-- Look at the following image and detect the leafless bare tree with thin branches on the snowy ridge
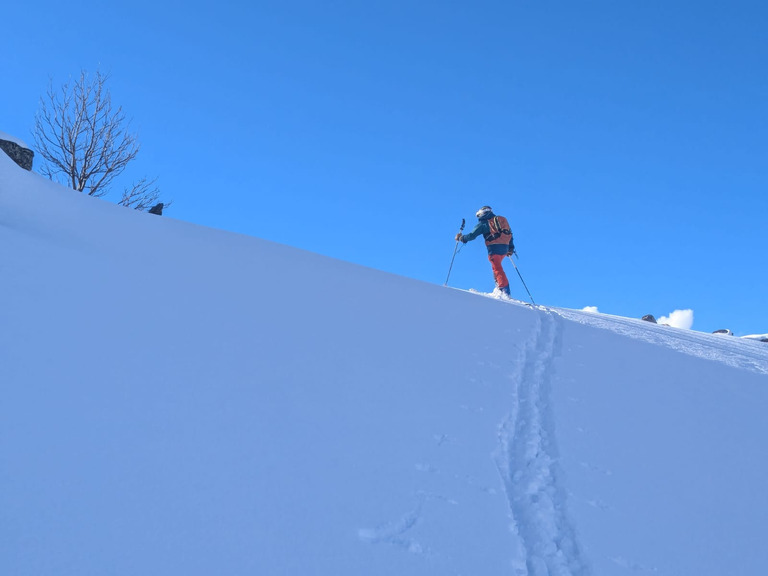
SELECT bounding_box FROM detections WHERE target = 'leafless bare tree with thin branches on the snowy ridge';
[34,71,166,210]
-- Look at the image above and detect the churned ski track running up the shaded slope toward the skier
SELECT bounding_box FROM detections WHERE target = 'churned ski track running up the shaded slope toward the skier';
[496,311,587,576]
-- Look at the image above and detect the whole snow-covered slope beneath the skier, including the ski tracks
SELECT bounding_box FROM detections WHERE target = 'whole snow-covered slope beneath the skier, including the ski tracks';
[0,153,768,576]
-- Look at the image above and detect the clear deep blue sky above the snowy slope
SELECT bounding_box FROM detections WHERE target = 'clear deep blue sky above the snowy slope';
[0,0,768,335]
